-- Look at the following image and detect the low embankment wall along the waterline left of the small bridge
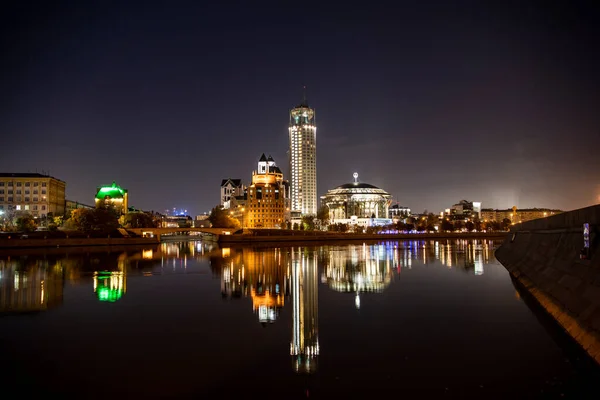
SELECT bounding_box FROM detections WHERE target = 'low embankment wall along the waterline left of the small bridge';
[0,237,160,250]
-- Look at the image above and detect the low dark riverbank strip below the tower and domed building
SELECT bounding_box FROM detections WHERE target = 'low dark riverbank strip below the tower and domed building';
[218,231,507,245]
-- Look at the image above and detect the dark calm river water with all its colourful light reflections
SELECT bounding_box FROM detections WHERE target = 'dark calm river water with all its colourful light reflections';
[0,240,600,399]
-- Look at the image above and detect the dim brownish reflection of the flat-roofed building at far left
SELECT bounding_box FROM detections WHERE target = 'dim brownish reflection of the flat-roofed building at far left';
[0,261,64,313]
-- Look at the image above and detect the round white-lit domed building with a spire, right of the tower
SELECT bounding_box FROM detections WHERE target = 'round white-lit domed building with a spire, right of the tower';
[321,172,392,227]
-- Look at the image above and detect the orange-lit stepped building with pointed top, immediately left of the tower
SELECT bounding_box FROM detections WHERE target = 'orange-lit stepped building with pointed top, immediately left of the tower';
[245,154,289,228]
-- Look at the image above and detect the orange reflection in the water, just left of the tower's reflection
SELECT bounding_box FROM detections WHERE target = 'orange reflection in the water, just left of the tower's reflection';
[221,249,289,323]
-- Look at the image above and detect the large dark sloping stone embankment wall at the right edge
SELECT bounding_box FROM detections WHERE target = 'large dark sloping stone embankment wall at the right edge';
[496,205,600,363]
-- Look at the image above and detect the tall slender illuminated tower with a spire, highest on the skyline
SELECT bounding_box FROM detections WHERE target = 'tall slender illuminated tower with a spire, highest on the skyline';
[289,89,317,215]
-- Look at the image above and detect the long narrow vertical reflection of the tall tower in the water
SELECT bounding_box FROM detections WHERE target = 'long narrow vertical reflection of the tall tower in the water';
[290,248,319,373]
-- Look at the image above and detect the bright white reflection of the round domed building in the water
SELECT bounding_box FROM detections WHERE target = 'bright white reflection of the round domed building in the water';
[325,244,397,308]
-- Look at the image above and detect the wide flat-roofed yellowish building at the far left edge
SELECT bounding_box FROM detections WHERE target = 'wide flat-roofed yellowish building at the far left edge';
[0,173,66,217]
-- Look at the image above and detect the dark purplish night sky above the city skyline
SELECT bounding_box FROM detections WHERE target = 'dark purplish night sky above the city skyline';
[0,1,600,215]
